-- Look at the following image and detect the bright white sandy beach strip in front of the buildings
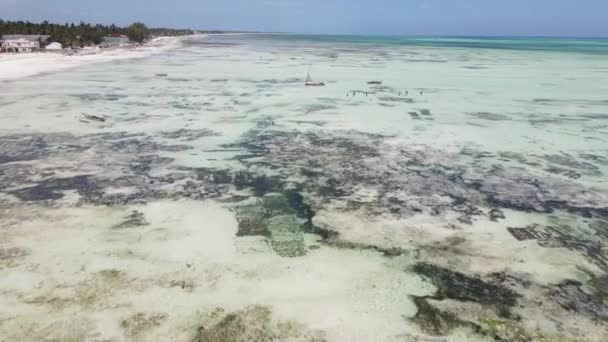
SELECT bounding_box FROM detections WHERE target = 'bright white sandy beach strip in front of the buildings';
[0,37,190,80]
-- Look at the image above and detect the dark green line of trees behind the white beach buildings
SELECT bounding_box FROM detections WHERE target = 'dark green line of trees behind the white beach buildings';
[0,19,194,48]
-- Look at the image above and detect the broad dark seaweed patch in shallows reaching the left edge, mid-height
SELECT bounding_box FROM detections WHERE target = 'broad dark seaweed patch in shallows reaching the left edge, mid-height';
[0,132,186,205]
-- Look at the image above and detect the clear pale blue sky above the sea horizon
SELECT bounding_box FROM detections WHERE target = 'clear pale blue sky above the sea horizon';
[0,0,608,37]
